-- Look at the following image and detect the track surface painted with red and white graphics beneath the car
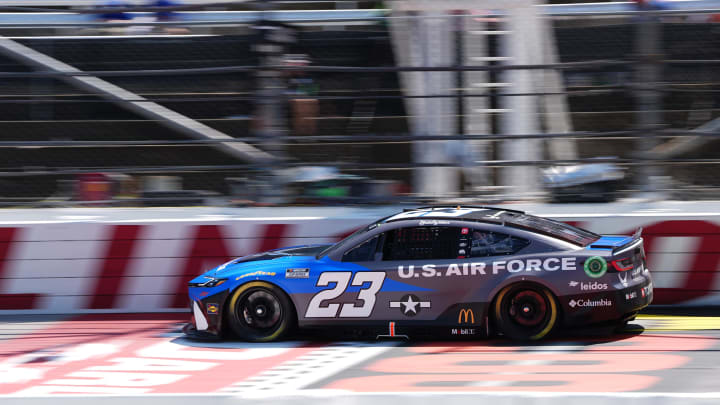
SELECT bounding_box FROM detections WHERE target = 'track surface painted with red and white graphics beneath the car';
[0,309,720,405]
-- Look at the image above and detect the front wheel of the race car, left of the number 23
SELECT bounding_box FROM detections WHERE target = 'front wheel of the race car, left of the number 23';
[225,281,297,342]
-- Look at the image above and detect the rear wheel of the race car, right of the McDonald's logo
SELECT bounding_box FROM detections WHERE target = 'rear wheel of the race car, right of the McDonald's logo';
[493,283,560,341]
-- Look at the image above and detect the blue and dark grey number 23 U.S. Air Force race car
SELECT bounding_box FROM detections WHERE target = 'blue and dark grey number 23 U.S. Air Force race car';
[186,206,653,342]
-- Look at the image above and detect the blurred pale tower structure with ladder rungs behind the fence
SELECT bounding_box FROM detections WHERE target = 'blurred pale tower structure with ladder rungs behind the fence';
[391,0,577,198]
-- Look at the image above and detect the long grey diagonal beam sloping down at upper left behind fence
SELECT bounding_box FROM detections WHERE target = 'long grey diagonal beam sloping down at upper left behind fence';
[0,37,275,162]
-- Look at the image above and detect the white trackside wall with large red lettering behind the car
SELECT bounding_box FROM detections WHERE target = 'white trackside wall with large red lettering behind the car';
[0,206,720,314]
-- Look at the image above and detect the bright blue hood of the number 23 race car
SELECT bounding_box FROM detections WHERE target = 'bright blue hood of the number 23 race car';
[210,244,332,277]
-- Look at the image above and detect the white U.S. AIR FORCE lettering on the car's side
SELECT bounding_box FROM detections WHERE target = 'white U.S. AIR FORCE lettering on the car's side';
[398,257,576,278]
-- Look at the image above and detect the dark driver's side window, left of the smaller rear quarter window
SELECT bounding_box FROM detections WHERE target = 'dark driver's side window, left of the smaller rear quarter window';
[383,226,460,260]
